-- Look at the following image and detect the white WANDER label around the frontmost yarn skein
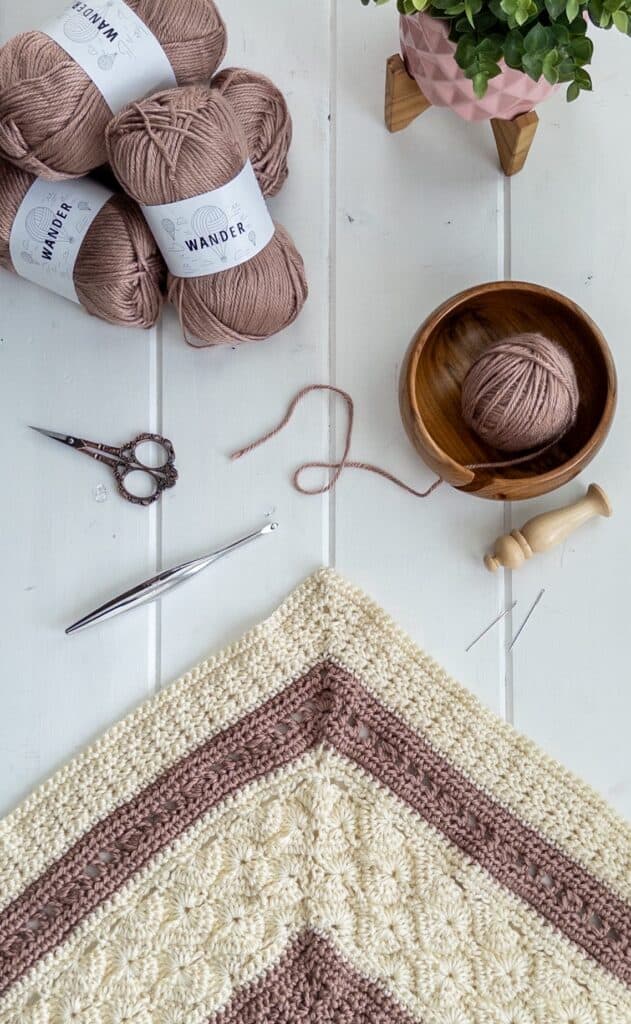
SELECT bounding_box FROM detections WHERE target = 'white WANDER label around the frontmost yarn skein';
[142,161,275,278]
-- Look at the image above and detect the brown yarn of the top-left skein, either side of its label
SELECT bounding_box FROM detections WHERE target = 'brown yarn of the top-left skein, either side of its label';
[0,0,226,181]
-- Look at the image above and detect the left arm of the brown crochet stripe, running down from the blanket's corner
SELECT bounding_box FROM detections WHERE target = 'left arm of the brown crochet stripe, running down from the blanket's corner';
[0,665,335,995]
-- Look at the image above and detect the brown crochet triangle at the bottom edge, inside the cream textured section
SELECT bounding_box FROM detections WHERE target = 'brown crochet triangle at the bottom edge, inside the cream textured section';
[209,932,422,1024]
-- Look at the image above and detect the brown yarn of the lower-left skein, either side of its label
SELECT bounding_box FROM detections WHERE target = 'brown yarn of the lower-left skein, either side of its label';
[0,160,166,328]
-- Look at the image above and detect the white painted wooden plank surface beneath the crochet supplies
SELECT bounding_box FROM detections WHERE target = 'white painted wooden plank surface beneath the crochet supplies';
[0,0,631,816]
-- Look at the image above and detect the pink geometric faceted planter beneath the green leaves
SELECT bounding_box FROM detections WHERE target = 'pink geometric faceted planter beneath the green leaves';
[401,13,557,121]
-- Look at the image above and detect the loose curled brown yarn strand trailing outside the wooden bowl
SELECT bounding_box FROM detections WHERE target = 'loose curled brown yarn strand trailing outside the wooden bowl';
[229,384,444,498]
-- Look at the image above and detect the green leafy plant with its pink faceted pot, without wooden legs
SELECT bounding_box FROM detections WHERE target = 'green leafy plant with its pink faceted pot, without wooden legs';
[362,0,631,120]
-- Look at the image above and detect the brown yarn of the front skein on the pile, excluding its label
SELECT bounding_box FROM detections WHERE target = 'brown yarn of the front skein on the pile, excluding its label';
[107,86,307,345]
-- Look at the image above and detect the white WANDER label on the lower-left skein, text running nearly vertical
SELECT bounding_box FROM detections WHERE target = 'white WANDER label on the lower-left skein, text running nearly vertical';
[9,178,114,302]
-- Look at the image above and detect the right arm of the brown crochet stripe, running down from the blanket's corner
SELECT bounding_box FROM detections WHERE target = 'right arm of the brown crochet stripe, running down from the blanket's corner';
[327,682,631,986]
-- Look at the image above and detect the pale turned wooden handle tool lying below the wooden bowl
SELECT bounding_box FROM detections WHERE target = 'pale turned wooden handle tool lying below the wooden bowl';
[485,483,613,572]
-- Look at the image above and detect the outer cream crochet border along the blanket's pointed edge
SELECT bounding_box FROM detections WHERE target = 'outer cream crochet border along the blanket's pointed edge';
[0,569,631,909]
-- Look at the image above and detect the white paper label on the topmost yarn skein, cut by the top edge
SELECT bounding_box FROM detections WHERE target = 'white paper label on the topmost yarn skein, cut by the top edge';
[41,0,177,114]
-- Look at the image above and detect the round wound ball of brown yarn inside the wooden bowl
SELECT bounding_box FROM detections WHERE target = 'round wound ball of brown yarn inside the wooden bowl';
[462,334,579,452]
